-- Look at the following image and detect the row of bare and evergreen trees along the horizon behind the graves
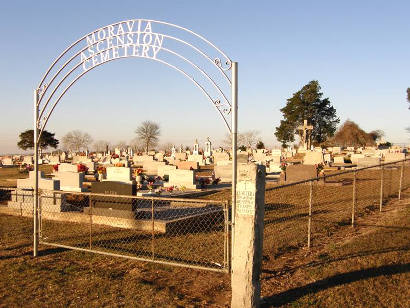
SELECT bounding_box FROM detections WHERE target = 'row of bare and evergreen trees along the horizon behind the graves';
[17,85,410,152]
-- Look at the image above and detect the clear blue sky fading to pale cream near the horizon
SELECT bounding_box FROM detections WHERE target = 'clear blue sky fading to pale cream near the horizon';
[0,0,410,153]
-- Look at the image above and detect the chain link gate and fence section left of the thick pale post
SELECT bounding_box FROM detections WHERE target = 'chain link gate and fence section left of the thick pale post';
[0,189,229,272]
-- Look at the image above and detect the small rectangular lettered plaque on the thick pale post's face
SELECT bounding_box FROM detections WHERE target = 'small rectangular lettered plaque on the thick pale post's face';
[236,181,256,216]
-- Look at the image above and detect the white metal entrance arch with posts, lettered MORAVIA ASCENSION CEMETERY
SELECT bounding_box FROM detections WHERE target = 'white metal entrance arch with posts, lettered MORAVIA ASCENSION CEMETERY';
[33,19,238,256]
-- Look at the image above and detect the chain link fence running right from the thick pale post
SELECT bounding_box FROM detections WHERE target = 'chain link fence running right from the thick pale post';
[263,159,410,264]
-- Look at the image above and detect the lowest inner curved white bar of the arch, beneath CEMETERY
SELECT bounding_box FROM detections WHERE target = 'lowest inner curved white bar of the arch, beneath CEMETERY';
[37,56,231,142]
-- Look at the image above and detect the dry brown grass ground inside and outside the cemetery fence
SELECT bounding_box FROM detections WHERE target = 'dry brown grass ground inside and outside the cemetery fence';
[0,164,410,307]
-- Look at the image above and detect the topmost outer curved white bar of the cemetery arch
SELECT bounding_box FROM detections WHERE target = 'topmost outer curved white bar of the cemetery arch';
[37,19,232,89]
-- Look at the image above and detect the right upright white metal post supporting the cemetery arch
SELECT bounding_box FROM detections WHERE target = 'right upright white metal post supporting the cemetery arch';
[231,62,238,264]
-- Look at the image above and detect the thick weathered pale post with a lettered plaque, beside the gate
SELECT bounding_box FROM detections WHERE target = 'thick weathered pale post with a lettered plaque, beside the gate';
[231,164,266,308]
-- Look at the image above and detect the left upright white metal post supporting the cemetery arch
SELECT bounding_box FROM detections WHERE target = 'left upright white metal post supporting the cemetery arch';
[33,89,39,257]
